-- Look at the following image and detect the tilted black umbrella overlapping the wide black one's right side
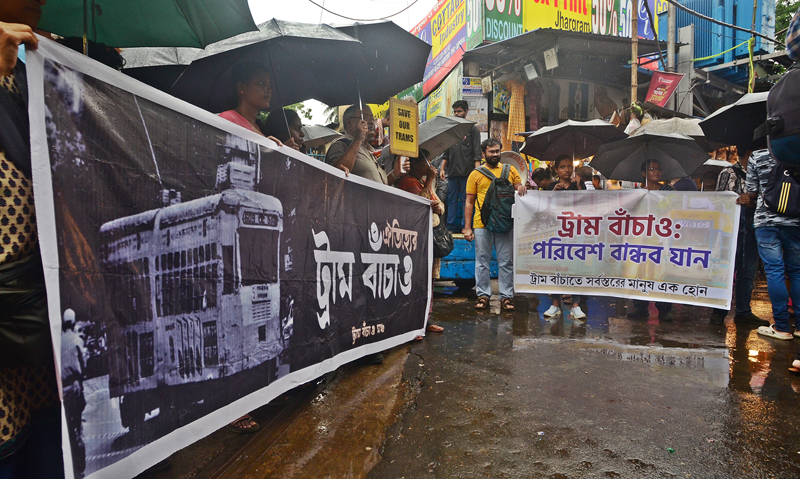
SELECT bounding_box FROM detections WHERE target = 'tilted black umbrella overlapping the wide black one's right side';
[336,21,431,105]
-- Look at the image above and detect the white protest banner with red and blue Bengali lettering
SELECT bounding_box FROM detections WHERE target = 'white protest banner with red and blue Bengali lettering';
[514,190,740,309]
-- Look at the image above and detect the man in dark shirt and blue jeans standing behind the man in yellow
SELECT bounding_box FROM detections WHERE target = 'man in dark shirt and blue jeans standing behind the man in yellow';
[439,100,481,233]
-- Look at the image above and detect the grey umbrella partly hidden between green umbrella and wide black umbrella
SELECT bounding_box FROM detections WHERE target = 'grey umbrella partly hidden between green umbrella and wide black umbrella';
[120,47,203,92]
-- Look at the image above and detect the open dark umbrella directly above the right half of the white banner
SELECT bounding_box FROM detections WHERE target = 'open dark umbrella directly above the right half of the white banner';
[589,132,708,182]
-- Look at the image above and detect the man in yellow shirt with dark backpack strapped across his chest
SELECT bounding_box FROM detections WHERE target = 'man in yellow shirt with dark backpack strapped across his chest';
[464,138,527,311]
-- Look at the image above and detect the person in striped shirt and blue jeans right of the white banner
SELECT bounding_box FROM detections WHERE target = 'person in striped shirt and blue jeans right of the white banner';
[737,150,800,340]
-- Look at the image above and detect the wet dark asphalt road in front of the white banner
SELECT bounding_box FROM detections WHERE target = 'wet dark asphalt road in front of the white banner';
[367,289,800,479]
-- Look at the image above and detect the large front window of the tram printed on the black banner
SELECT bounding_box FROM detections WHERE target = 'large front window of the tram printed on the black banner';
[239,228,280,286]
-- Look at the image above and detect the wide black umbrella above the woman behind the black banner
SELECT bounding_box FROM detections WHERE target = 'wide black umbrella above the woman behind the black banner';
[175,19,363,112]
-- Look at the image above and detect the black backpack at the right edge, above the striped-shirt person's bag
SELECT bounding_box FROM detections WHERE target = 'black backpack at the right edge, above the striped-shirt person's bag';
[766,62,800,166]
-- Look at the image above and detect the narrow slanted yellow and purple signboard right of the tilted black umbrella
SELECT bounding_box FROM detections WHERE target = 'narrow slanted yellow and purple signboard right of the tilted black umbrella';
[411,0,467,95]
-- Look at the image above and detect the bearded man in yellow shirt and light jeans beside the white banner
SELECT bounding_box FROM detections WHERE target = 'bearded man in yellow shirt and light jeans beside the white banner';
[464,138,527,311]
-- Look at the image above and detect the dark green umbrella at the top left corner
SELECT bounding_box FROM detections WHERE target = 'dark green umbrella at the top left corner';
[39,0,257,48]
